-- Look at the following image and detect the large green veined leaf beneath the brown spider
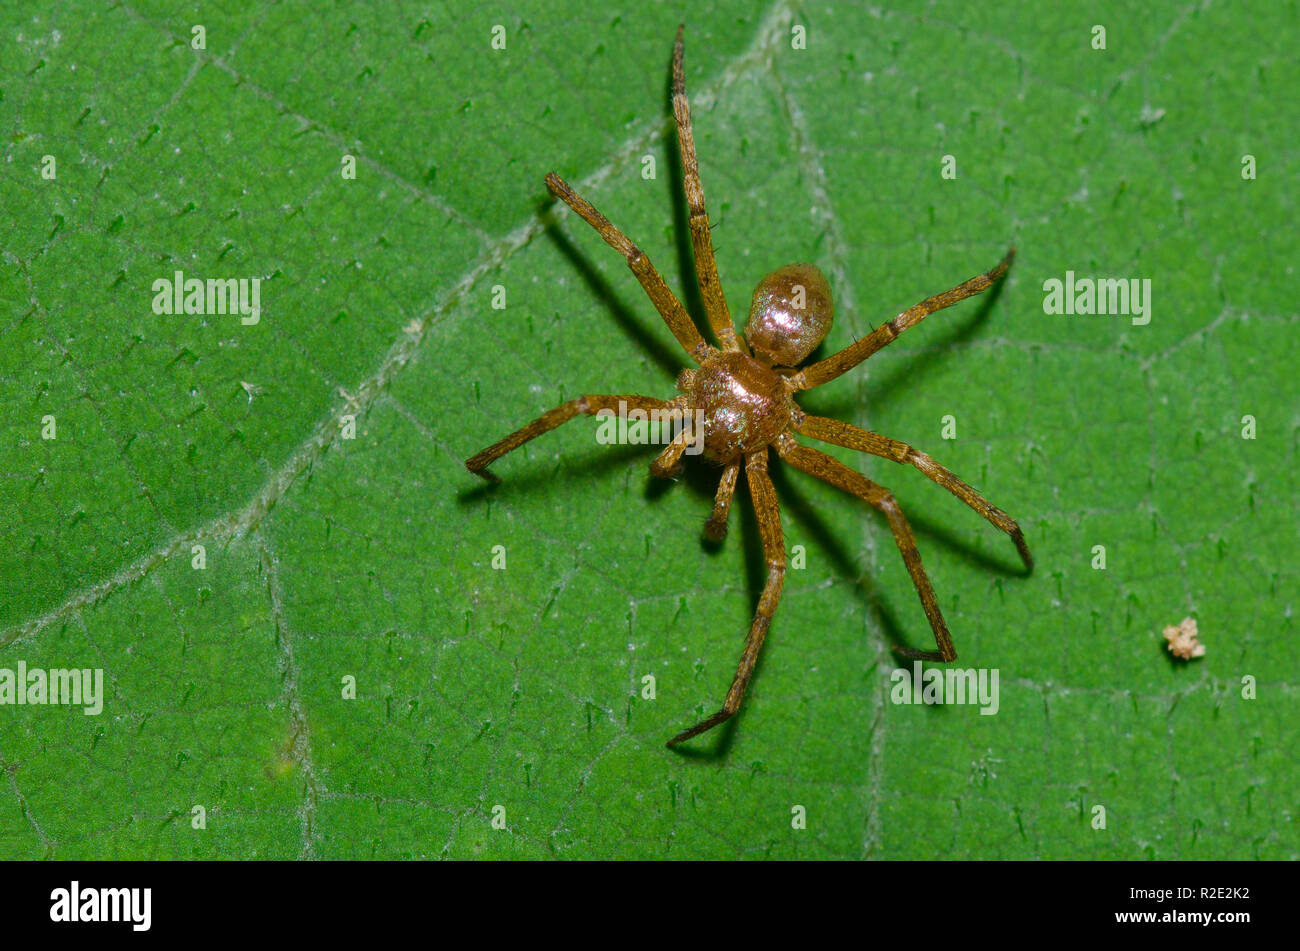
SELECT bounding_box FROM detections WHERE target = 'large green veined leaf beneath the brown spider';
[0,0,1300,859]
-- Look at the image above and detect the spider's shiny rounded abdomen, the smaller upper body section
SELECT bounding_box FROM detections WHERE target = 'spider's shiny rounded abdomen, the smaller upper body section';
[745,264,835,366]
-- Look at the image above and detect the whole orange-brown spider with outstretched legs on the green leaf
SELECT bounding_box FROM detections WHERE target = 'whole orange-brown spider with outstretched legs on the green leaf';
[465,26,1034,747]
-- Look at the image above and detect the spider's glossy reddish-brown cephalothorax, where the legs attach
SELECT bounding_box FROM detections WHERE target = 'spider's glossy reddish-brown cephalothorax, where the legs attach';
[677,351,790,465]
